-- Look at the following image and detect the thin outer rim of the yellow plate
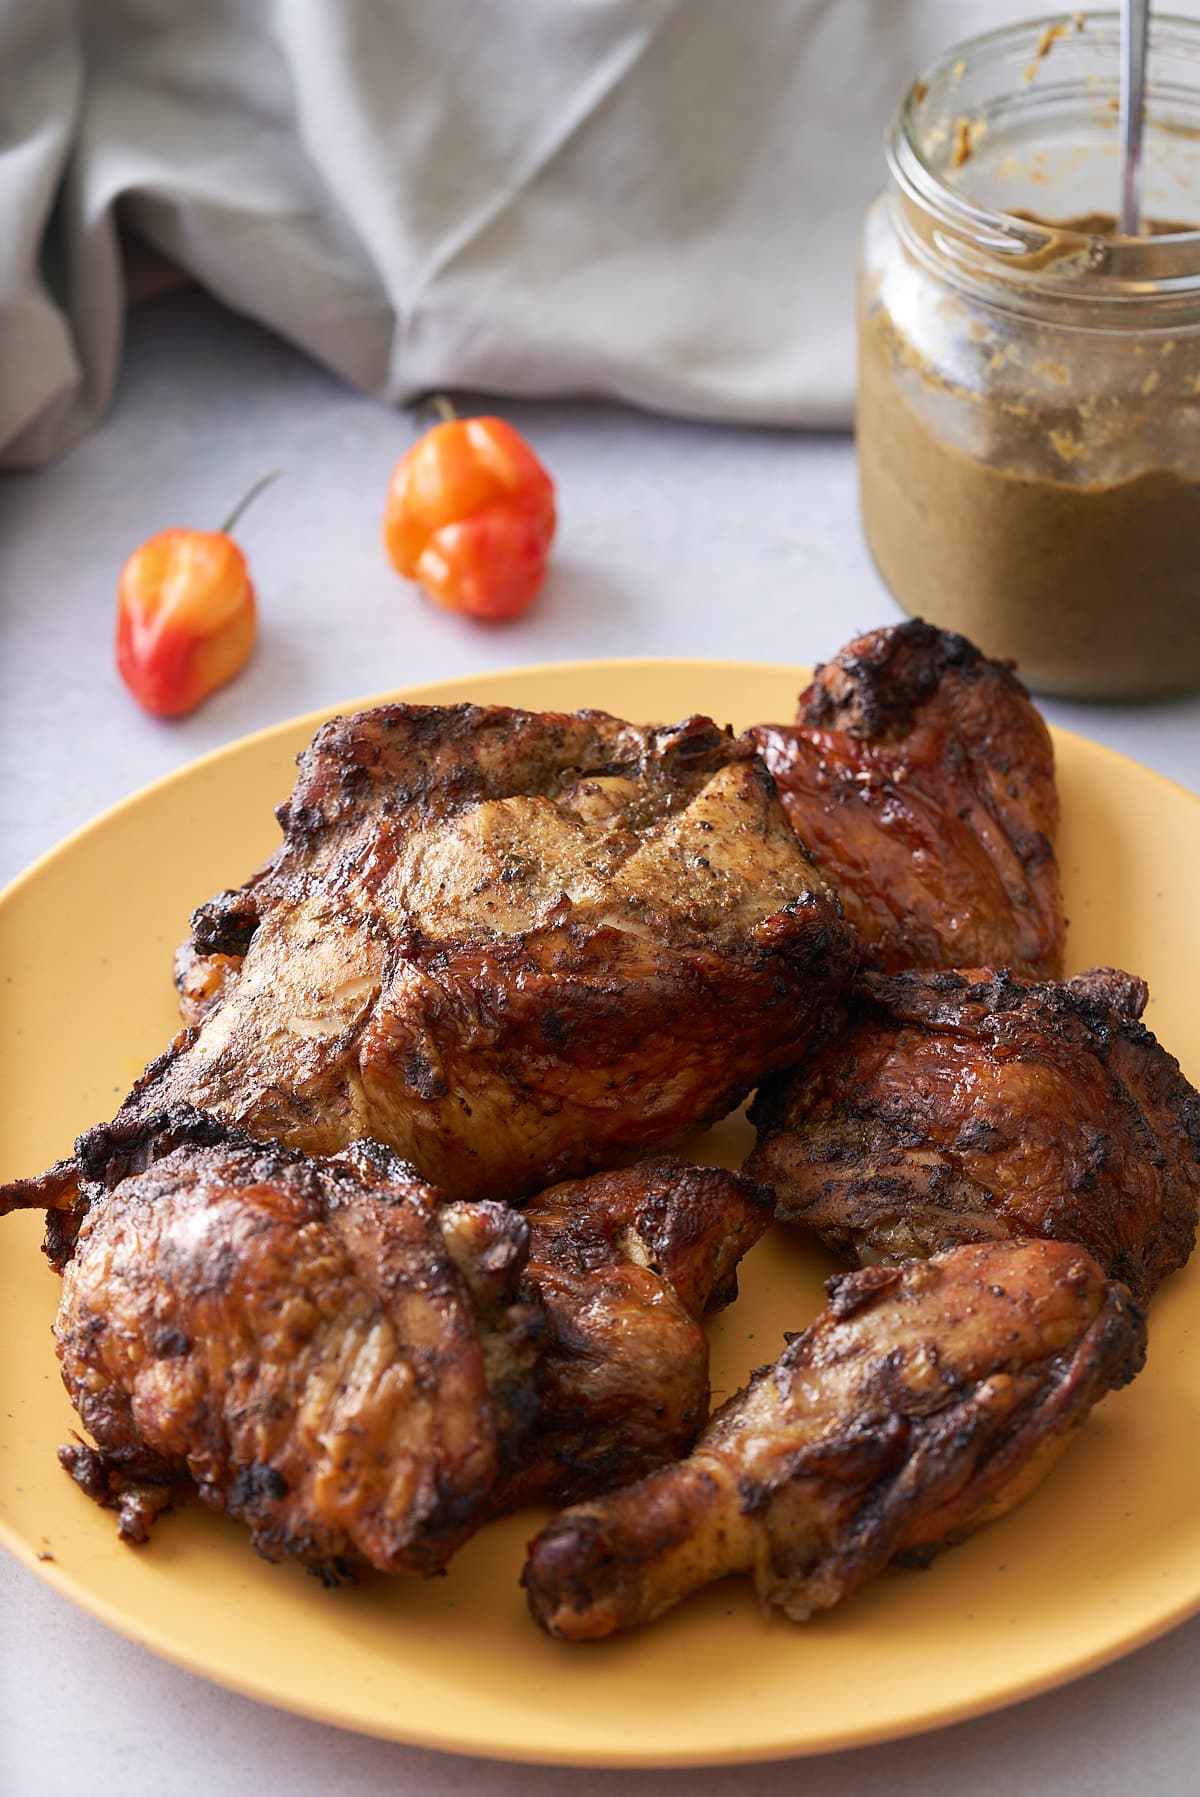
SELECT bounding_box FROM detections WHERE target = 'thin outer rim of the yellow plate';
[0,656,1200,1770]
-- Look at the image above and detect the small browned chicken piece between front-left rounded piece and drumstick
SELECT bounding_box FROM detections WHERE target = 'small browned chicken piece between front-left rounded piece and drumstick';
[498,1157,772,1508]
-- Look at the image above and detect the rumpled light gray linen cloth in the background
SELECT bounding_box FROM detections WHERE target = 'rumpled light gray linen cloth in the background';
[0,0,1085,467]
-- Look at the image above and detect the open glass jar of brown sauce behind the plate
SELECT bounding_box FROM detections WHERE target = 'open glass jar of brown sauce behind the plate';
[857,14,1200,697]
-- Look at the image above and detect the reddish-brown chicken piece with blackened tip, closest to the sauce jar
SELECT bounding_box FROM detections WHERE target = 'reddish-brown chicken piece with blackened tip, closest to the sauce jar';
[753,620,1065,979]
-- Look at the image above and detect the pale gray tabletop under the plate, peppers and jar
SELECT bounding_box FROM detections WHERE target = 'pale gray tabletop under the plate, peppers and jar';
[0,295,1200,1797]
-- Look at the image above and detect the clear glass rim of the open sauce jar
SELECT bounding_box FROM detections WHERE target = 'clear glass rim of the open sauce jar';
[886,11,1200,298]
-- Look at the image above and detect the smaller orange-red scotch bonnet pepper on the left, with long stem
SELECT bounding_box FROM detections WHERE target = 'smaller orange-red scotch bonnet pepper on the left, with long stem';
[117,474,275,717]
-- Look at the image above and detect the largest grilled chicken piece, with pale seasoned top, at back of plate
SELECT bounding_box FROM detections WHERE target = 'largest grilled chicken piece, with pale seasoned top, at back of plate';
[9,704,853,1206]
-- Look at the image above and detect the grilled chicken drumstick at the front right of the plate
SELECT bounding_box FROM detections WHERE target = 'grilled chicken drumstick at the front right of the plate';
[523,1242,1144,1641]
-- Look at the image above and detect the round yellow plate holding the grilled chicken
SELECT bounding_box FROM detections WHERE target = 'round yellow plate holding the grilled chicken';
[0,661,1200,1765]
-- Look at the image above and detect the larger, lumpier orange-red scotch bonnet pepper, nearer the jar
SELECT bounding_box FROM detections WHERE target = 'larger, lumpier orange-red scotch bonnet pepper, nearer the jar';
[383,417,557,618]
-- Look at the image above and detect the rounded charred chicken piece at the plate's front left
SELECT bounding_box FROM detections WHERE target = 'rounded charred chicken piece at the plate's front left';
[31,1112,543,1581]
